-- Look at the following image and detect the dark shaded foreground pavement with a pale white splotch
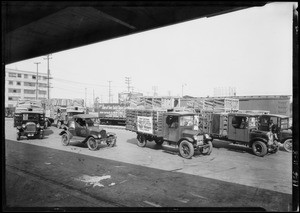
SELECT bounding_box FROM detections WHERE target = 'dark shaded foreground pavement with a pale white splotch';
[6,140,292,211]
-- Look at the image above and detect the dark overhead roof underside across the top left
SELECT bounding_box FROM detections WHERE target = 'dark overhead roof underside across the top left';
[2,1,267,64]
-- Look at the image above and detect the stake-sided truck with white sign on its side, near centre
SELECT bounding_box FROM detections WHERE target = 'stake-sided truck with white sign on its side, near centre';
[125,109,212,159]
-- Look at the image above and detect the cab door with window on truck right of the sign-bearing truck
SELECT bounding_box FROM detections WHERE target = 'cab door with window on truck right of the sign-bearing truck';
[228,116,249,142]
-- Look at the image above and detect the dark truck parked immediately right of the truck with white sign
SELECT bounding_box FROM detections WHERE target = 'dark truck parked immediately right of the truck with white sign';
[209,113,279,157]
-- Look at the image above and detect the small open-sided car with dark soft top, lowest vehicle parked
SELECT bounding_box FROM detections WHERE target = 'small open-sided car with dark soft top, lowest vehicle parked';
[59,114,117,151]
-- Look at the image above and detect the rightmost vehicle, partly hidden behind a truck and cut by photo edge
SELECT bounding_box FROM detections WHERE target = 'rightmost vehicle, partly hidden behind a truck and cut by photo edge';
[258,114,293,152]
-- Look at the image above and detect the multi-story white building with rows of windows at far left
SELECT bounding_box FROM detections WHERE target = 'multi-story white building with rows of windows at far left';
[5,68,50,107]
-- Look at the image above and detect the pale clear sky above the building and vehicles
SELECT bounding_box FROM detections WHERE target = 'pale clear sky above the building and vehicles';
[6,2,296,105]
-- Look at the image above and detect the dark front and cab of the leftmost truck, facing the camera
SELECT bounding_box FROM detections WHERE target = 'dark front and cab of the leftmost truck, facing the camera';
[14,111,45,140]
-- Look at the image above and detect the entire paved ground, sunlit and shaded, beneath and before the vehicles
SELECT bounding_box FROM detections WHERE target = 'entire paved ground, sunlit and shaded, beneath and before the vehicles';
[5,118,292,211]
